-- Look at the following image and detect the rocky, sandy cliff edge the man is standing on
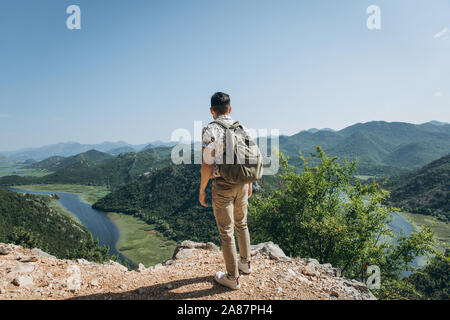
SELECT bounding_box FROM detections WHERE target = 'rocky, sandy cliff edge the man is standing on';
[0,241,375,300]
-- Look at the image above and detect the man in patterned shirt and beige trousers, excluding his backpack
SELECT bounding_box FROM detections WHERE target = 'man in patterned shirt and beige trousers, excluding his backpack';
[199,92,252,289]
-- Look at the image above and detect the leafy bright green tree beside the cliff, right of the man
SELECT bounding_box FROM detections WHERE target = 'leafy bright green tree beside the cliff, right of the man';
[249,147,434,288]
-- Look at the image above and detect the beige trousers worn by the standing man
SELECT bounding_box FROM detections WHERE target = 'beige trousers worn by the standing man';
[212,178,250,278]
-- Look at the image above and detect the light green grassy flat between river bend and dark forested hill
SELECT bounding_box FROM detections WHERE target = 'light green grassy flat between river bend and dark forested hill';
[108,213,176,267]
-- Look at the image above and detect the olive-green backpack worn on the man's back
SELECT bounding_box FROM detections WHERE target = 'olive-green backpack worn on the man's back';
[212,120,263,184]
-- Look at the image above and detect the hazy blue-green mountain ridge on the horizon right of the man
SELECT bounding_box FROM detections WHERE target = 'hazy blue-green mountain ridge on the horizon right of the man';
[280,121,450,176]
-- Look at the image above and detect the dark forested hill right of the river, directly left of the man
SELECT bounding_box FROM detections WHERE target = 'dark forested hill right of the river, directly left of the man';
[94,165,218,241]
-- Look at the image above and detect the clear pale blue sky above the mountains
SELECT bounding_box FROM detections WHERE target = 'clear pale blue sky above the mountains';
[0,0,450,150]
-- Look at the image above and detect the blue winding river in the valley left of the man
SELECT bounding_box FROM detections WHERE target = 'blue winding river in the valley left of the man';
[10,188,135,267]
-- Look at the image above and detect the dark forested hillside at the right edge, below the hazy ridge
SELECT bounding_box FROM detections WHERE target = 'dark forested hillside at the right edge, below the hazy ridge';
[384,154,450,221]
